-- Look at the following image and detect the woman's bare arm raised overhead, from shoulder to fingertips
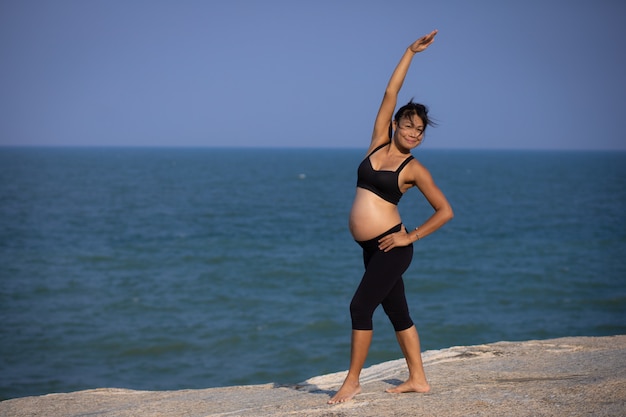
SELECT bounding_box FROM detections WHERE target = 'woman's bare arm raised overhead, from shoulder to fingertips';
[370,30,437,151]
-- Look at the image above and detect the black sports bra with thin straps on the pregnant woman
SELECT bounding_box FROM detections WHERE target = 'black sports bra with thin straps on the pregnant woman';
[356,142,413,205]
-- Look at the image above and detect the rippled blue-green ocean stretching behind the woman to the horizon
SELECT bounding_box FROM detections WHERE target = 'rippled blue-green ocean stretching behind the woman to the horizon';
[0,148,626,399]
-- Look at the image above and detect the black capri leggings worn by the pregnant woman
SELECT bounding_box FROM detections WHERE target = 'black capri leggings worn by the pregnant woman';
[350,224,413,332]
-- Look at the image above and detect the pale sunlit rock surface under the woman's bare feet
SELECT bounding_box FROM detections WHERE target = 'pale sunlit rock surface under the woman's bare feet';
[0,335,626,417]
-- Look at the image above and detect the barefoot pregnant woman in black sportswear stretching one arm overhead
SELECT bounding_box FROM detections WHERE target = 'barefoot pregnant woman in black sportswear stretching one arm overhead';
[328,31,453,404]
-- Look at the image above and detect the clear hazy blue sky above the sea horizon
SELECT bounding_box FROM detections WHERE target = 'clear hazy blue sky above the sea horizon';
[0,0,626,150]
